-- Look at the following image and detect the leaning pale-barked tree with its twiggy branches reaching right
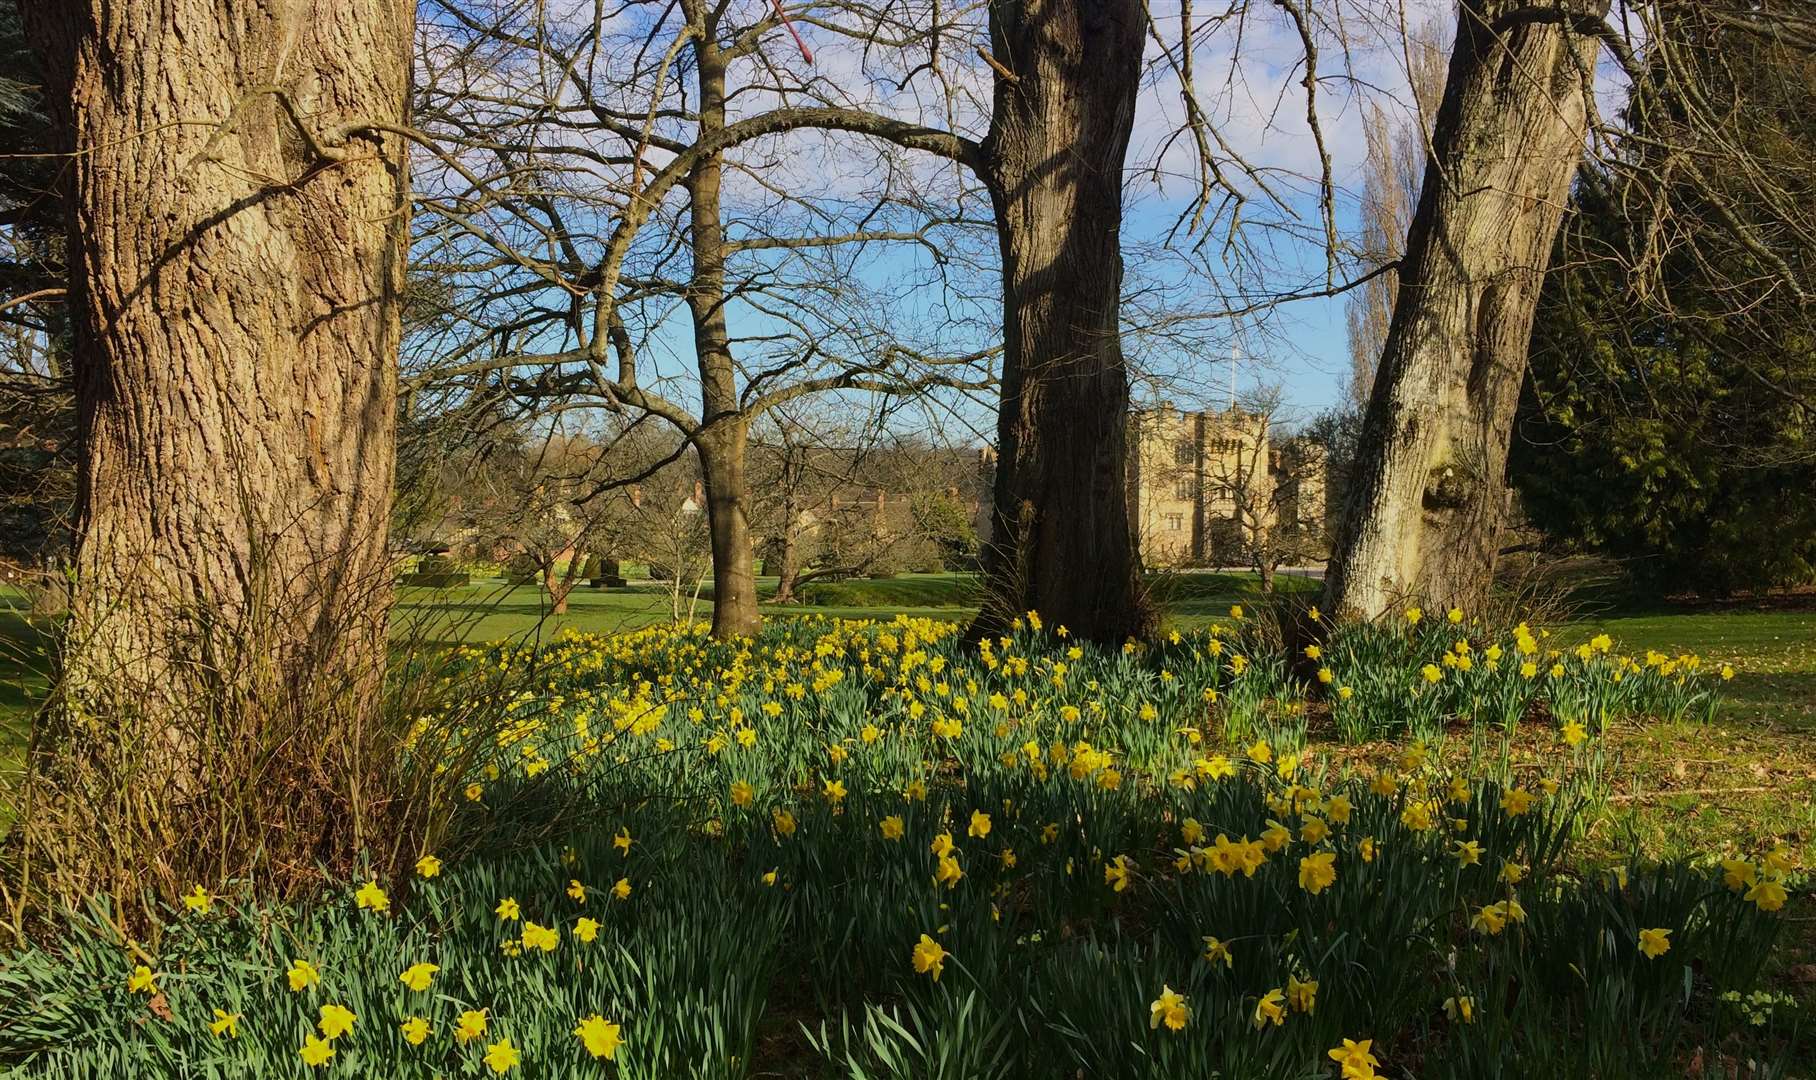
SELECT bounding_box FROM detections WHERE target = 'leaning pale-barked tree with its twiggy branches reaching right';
[1327,0,1816,615]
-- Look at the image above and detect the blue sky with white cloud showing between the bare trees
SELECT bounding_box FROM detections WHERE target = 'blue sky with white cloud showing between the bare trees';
[415,0,1451,434]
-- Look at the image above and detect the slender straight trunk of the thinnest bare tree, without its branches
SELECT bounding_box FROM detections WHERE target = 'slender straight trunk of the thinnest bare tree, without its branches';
[686,33,763,641]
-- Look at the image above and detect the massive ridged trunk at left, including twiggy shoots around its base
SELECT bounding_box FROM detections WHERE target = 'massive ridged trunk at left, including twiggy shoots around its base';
[24,0,412,918]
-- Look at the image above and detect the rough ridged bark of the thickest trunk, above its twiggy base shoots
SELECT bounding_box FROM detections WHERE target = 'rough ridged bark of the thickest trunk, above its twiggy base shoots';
[25,0,412,751]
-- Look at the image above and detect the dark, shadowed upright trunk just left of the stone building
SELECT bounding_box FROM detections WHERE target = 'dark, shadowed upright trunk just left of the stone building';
[973,0,1151,643]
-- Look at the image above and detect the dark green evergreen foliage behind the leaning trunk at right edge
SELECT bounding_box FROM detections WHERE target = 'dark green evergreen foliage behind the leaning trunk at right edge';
[1509,4,1816,594]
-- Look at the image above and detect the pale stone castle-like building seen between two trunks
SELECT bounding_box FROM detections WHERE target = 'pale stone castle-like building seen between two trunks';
[1128,405,1329,566]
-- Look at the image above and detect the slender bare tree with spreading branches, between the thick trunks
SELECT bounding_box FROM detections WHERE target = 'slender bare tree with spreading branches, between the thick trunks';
[404,0,995,637]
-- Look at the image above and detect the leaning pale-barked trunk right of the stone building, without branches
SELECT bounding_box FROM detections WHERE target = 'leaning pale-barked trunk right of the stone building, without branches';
[1326,0,1609,617]
